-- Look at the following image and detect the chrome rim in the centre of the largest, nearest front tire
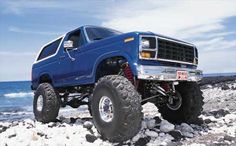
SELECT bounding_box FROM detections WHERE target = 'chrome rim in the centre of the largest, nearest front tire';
[99,96,114,122]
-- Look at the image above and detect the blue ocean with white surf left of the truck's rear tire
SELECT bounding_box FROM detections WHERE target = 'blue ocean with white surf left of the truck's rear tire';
[0,81,33,121]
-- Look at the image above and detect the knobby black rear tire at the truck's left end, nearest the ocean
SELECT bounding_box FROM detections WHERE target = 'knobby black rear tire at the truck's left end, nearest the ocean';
[33,83,60,123]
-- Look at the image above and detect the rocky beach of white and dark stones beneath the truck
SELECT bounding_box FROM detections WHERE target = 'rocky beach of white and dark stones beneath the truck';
[0,77,236,146]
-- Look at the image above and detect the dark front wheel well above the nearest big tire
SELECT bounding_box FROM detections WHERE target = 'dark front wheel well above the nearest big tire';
[95,56,127,82]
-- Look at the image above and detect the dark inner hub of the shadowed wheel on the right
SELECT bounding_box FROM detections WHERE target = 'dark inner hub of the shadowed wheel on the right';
[167,91,182,110]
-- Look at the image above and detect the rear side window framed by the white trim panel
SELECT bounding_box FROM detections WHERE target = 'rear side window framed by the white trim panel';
[37,38,61,60]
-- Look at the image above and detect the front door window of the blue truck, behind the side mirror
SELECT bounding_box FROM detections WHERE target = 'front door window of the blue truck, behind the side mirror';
[68,30,84,48]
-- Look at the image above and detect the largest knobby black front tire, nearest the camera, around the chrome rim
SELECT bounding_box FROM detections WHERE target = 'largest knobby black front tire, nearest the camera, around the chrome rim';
[91,75,143,142]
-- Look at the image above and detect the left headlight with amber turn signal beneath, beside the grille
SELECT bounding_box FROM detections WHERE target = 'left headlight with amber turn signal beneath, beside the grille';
[139,36,157,59]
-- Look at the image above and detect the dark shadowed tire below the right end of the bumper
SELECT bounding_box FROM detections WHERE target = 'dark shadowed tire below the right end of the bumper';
[158,82,203,123]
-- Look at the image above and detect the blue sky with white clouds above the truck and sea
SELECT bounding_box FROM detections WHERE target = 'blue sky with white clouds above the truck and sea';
[0,0,236,81]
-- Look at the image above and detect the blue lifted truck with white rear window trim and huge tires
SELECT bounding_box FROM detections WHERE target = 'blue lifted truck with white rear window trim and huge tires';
[32,26,203,142]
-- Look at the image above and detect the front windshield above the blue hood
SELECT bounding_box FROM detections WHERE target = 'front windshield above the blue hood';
[85,27,121,41]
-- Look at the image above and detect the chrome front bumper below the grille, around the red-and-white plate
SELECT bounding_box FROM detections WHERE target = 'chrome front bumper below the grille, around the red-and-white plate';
[137,65,202,82]
